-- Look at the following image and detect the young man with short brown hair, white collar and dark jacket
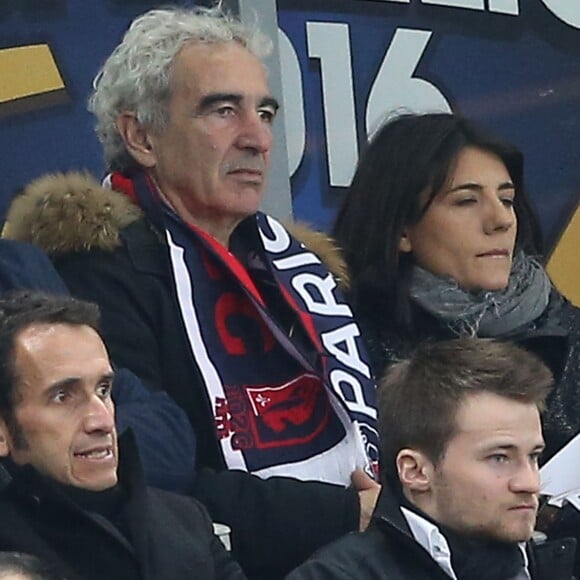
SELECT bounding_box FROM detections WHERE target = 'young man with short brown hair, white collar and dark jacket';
[288,338,575,580]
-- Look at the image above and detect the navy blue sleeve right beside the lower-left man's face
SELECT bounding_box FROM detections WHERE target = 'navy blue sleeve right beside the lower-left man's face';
[113,369,195,493]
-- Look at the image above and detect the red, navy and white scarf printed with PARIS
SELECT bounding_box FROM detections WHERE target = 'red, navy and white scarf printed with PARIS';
[110,174,378,485]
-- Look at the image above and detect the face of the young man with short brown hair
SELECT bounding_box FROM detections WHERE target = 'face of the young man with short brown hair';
[416,392,544,543]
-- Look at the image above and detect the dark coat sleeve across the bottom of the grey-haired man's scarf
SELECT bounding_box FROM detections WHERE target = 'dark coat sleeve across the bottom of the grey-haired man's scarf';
[195,469,360,580]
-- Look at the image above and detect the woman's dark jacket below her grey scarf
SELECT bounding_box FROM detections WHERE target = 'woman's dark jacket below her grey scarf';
[354,288,580,577]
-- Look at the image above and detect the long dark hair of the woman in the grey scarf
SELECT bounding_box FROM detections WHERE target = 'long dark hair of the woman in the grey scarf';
[333,113,542,330]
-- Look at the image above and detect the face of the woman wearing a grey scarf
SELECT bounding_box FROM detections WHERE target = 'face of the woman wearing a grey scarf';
[399,147,517,291]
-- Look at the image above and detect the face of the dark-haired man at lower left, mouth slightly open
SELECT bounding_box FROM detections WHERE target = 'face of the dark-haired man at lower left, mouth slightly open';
[0,324,117,491]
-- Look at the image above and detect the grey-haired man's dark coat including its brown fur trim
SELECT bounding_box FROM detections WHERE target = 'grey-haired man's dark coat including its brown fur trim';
[5,174,359,580]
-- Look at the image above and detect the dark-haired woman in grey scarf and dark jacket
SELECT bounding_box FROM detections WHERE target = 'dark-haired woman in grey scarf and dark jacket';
[334,113,580,455]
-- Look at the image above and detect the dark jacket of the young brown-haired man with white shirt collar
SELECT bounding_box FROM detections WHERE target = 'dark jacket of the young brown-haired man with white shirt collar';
[286,487,574,580]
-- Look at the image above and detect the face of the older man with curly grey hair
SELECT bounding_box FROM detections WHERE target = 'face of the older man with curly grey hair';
[141,42,277,244]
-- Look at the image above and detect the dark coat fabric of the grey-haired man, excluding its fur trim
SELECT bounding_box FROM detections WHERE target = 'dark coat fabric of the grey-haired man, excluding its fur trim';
[55,221,359,580]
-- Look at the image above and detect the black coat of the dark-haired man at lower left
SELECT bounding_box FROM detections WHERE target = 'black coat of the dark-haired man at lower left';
[0,437,245,580]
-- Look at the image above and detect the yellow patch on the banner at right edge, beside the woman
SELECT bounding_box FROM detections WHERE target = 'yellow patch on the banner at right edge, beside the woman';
[548,208,580,306]
